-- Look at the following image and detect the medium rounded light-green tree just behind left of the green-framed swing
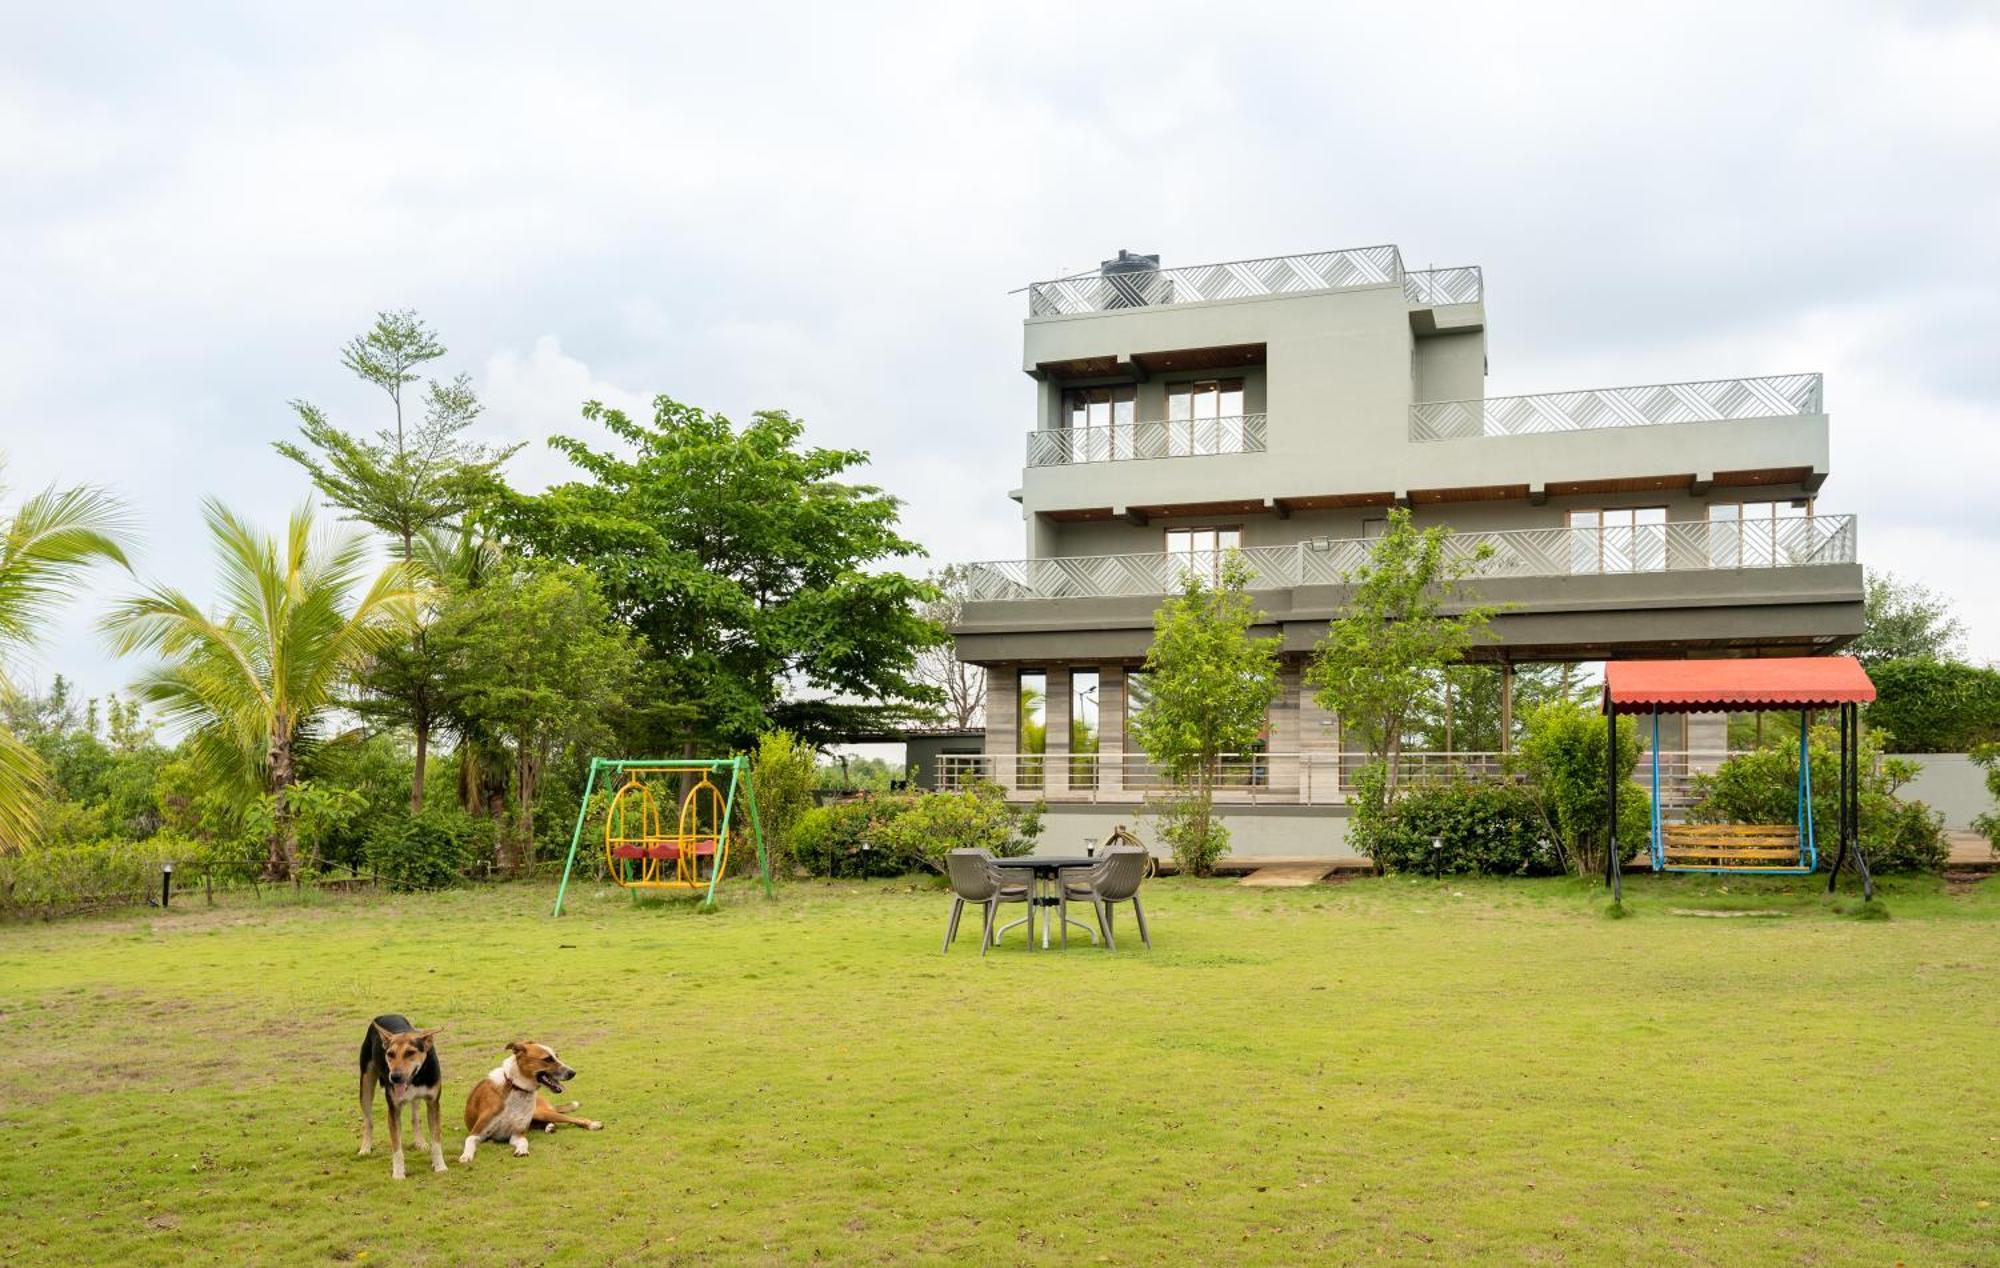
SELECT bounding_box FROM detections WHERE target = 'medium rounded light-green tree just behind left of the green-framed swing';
[432,562,636,872]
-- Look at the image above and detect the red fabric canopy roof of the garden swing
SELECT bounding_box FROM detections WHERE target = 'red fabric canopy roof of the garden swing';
[1604,656,1874,714]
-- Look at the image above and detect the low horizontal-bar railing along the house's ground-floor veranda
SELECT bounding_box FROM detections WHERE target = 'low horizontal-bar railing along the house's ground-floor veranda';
[936,750,1728,804]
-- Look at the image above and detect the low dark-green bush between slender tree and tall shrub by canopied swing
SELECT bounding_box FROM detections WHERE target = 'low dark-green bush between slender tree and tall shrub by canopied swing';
[1366,780,1564,876]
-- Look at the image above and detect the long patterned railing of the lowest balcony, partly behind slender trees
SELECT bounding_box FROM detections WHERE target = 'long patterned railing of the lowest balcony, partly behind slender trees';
[964,516,1856,602]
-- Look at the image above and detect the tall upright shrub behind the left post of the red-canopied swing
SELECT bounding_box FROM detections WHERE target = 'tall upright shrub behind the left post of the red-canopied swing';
[1512,700,1652,876]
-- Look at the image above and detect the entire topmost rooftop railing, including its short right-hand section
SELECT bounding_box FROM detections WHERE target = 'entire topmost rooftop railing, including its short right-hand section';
[1028,246,1486,318]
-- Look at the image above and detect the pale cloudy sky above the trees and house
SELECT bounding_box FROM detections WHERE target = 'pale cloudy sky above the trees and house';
[0,0,2000,692]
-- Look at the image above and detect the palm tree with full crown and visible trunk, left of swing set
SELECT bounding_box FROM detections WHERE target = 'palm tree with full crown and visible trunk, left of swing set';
[104,500,416,880]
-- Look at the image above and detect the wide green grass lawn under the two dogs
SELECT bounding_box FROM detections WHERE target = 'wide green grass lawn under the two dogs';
[0,876,2000,1264]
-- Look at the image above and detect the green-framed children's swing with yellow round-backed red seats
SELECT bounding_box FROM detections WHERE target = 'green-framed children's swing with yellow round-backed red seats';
[554,756,772,916]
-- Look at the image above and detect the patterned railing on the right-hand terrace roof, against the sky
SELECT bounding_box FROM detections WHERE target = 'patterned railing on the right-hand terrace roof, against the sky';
[1410,374,1824,440]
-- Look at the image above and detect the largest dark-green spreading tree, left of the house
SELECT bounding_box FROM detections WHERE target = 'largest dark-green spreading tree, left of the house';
[498,396,944,752]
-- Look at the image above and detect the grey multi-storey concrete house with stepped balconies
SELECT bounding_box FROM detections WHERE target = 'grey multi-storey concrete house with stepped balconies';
[940,246,1862,854]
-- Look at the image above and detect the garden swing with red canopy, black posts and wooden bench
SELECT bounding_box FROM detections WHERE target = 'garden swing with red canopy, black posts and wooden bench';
[1604,656,1876,900]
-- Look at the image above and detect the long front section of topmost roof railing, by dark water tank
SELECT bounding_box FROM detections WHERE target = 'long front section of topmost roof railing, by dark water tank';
[1028,246,1404,316]
